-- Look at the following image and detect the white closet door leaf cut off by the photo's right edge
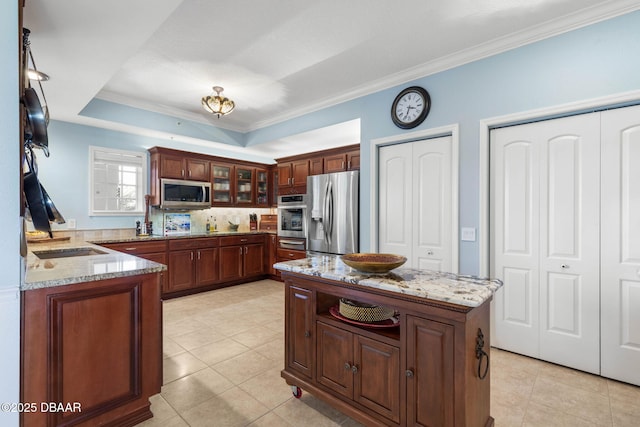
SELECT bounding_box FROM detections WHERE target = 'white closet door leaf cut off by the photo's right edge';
[600,107,640,385]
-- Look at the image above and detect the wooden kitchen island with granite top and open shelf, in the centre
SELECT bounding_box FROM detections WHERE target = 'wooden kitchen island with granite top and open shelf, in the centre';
[275,255,502,427]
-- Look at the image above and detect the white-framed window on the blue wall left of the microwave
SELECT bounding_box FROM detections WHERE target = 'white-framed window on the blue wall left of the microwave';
[89,147,147,215]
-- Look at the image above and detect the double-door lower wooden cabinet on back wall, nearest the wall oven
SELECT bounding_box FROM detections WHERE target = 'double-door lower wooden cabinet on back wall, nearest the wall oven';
[220,234,265,282]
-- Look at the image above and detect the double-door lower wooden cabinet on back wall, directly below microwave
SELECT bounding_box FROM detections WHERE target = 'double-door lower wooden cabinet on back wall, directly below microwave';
[163,237,220,293]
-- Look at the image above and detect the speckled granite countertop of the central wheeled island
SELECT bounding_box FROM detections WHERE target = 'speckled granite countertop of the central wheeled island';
[274,254,502,307]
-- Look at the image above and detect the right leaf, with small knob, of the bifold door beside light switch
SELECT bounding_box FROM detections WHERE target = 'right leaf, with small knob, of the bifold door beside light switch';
[537,113,600,374]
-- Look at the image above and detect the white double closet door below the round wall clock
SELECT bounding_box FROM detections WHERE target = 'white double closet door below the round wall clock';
[378,136,457,272]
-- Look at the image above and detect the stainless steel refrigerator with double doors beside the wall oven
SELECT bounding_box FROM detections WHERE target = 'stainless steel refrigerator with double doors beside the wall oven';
[307,171,359,254]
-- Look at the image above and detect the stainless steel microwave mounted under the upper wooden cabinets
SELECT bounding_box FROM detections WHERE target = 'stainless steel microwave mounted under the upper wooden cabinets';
[160,178,211,209]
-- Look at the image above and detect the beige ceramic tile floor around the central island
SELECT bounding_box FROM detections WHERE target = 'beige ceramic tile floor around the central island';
[140,280,640,427]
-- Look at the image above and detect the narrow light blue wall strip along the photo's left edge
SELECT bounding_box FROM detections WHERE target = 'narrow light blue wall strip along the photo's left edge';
[0,0,21,427]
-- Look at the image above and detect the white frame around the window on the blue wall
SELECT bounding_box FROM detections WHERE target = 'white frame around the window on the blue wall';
[89,146,148,216]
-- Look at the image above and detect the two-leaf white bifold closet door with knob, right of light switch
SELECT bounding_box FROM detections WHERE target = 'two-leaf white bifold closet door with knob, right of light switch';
[490,113,600,373]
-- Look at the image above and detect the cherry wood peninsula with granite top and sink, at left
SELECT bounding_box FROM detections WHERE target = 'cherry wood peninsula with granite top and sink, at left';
[20,242,166,427]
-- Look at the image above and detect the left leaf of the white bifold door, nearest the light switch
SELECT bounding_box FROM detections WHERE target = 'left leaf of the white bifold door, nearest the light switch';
[490,128,540,357]
